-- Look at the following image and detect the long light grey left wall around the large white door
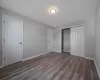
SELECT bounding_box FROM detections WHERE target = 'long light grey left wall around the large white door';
[0,8,52,65]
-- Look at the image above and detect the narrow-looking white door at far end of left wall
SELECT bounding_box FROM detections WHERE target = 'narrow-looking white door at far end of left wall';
[48,28,53,52]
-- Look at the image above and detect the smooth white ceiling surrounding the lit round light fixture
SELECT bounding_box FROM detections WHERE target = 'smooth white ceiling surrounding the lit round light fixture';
[0,0,98,27]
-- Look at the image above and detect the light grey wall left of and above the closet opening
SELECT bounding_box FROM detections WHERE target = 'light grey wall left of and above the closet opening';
[54,20,84,52]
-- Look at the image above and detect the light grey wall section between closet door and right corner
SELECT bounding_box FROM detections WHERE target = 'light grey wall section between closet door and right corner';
[85,15,95,58]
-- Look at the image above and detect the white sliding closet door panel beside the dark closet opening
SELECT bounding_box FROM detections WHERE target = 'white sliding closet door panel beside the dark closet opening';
[71,26,84,57]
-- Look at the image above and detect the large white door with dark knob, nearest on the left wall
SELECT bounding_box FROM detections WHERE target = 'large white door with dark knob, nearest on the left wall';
[4,17,23,66]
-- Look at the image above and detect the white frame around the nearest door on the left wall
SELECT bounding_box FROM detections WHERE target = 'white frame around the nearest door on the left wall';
[2,15,23,67]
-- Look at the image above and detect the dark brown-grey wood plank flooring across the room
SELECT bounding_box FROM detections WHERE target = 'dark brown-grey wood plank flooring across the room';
[0,52,99,80]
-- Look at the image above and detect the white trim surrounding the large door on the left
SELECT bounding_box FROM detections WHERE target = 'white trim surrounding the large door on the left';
[2,15,23,67]
